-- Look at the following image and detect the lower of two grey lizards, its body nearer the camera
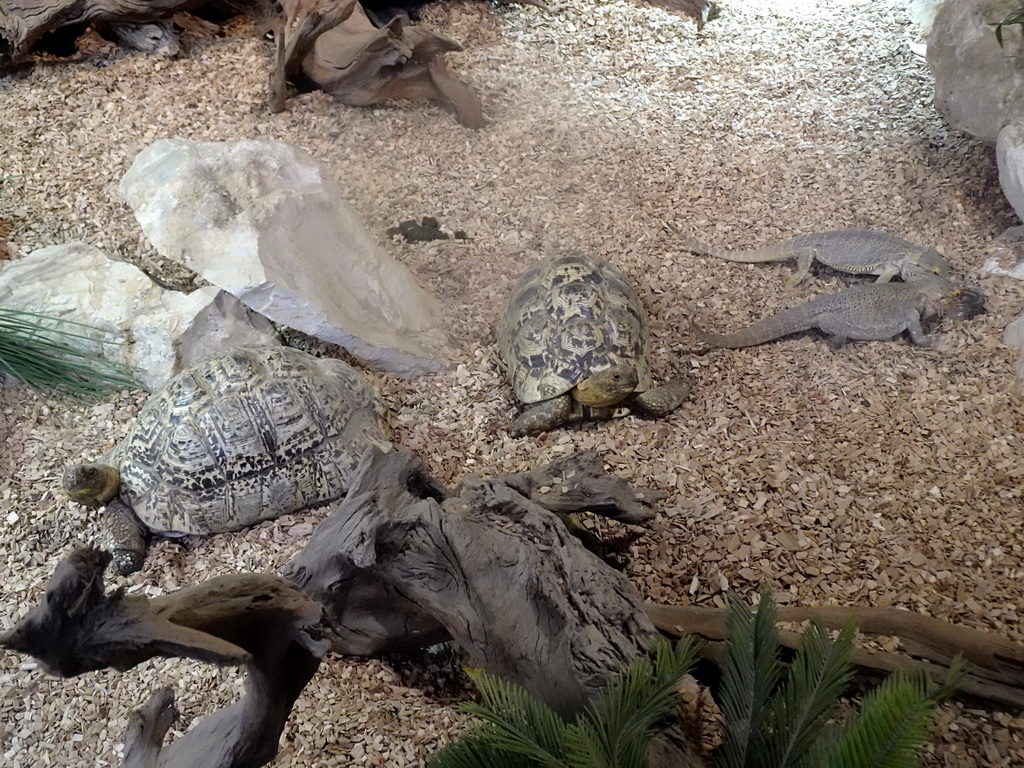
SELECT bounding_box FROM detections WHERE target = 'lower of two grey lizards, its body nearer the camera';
[690,278,985,349]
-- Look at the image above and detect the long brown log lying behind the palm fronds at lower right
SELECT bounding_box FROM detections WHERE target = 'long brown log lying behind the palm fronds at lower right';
[647,603,1024,708]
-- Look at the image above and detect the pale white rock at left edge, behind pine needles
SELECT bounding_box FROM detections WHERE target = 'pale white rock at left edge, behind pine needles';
[0,243,272,389]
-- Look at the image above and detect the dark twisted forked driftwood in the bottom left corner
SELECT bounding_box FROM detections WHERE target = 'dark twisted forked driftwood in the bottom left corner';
[0,548,327,768]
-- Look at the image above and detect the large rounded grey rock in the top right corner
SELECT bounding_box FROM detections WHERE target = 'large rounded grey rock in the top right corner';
[928,0,1024,141]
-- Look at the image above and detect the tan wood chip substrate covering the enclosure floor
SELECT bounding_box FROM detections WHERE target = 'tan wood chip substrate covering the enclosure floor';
[0,0,1024,768]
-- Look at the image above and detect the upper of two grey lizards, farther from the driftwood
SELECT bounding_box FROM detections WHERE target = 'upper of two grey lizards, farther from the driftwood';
[669,228,949,288]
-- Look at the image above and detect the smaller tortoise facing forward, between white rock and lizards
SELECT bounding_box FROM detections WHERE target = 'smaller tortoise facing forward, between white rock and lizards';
[495,253,691,437]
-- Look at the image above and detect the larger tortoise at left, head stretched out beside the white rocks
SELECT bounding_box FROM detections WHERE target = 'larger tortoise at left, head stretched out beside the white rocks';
[63,347,391,574]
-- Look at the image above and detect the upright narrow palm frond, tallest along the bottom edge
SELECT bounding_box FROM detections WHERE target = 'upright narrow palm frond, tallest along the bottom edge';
[716,592,781,768]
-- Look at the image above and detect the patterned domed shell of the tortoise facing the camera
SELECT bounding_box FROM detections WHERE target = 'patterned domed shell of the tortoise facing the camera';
[495,254,652,403]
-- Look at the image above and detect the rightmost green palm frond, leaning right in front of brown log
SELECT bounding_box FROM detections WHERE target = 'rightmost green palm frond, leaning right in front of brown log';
[821,656,964,768]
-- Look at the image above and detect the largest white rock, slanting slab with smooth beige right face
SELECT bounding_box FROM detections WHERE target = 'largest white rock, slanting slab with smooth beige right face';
[121,139,444,376]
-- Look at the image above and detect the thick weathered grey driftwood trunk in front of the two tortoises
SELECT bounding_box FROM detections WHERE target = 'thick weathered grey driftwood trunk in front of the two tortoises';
[286,450,654,714]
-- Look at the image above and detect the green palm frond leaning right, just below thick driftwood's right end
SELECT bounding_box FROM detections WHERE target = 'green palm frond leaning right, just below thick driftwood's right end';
[565,638,699,768]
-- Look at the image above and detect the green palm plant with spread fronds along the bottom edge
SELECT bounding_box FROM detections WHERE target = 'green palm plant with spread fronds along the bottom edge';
[427,593,962,768]
